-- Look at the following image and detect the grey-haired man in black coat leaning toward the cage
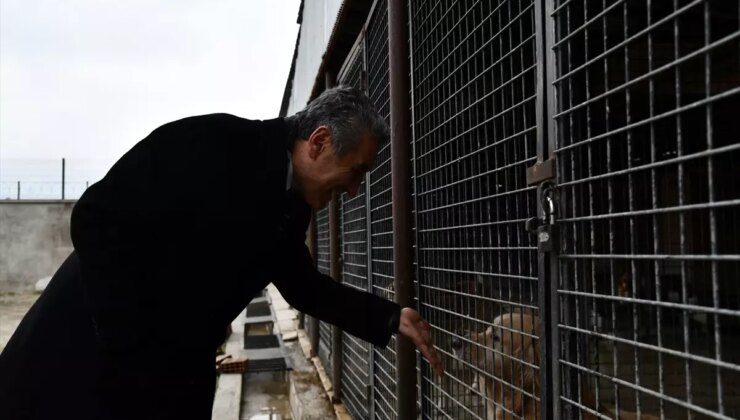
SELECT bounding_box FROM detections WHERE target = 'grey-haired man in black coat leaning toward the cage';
[0,87,441,419]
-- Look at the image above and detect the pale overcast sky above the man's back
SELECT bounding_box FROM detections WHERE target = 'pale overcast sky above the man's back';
[0,0,300,179]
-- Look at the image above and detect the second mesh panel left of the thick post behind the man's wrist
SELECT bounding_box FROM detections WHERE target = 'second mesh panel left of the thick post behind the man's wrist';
[340,40,371,419]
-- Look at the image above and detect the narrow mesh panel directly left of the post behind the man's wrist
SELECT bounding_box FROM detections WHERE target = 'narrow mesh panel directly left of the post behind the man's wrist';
[365,1,397,419]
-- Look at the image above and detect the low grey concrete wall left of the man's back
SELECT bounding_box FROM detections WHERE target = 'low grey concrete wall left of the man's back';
[0,200,75,293]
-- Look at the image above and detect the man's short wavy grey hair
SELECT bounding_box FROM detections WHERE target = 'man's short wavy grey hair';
[285,86,390,156]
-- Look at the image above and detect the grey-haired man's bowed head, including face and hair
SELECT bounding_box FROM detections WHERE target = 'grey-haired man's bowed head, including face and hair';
[286,86,390,209]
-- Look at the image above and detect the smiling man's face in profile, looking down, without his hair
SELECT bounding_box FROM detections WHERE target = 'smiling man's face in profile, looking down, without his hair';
[294,126,378,209]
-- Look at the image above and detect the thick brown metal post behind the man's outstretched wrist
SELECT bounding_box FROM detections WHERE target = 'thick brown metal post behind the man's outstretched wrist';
[388,0,416,419]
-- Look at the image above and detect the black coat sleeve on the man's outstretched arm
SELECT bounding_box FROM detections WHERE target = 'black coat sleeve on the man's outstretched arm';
[273,243,401,347]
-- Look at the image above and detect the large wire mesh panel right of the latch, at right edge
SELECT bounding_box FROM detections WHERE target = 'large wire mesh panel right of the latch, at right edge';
[552,0,740,418]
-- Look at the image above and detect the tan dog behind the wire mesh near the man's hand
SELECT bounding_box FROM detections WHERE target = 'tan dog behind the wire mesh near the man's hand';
[452,311,657,420]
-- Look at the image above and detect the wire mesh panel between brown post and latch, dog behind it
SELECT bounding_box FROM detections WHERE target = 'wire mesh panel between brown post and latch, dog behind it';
[410,1,539,419]
